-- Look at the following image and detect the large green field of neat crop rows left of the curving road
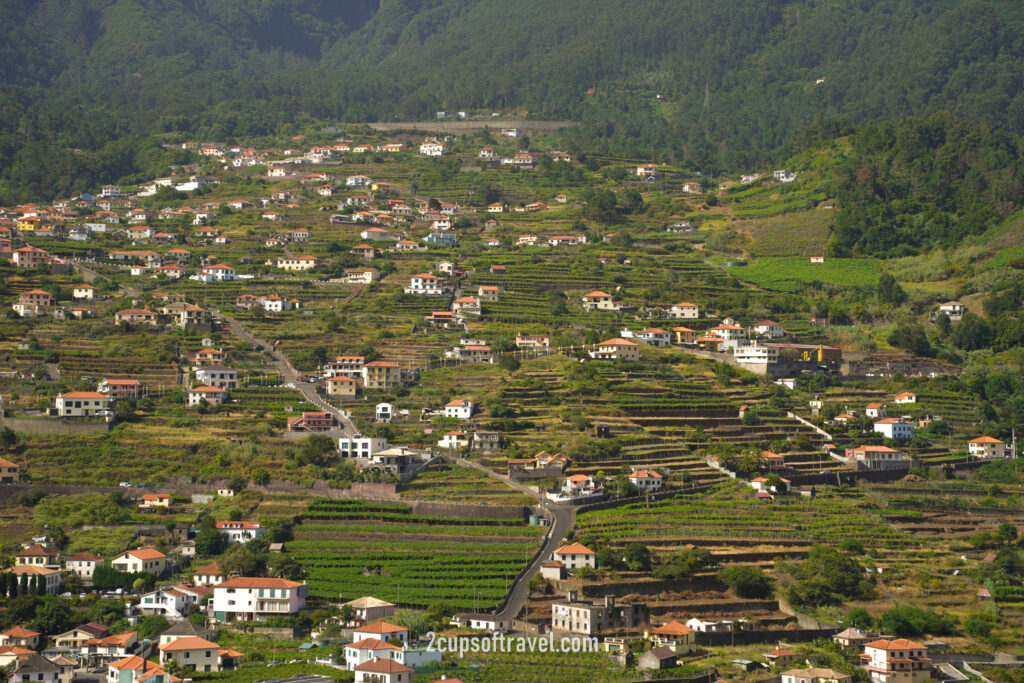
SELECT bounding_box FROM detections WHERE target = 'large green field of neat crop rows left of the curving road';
[289,500,543,610]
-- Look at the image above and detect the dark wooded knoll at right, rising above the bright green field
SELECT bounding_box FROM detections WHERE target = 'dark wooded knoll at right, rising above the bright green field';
[829,114,1024,256]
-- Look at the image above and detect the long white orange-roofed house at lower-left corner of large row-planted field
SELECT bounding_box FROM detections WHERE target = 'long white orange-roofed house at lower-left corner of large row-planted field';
[207,577,308,622]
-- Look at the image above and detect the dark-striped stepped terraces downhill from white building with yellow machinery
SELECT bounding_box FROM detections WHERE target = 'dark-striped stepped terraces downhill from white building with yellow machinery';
[498,357,838,484]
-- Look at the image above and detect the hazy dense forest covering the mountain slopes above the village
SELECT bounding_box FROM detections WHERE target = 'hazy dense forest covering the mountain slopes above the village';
[0,0,1024,204]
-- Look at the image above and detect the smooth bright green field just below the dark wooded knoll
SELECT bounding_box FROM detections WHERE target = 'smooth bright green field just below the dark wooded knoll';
[729,257,881,292]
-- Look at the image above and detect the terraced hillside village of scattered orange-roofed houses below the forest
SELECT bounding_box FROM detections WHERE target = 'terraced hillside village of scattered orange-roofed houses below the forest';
[0,126,1024,683]
